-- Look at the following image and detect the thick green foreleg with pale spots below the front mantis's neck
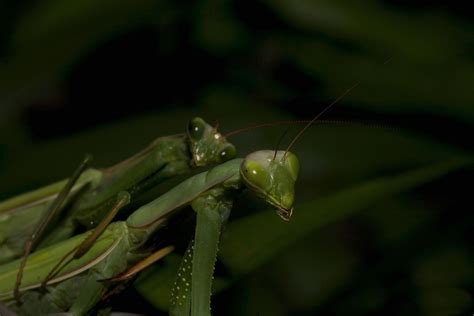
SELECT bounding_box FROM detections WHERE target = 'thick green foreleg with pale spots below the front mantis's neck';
[170,189,232,316]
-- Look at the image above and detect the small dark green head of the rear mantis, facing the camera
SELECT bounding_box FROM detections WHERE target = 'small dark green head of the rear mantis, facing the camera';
[187,117,236,166]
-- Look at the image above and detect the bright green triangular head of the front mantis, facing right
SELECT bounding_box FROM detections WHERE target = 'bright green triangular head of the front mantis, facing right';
[240,150,299,221]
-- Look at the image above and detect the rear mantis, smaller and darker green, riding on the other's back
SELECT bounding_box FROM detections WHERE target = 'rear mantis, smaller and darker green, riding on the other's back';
[0,118,235,263]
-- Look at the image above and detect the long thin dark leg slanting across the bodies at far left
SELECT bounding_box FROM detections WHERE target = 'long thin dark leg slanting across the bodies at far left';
[14,155,92,302]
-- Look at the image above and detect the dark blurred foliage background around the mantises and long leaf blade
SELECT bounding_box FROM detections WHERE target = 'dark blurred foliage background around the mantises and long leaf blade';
[0,0,474,315]
